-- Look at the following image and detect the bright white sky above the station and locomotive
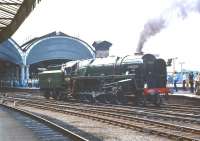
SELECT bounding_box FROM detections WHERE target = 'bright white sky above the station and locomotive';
[12,0,200,70]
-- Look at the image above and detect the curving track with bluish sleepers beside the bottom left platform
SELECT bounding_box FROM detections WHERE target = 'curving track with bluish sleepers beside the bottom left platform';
[0,104,88,141]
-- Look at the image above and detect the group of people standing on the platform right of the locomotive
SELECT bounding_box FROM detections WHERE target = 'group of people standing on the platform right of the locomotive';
[173,72,200,93]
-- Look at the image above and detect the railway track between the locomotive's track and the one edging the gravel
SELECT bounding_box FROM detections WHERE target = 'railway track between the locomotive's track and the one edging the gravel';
[61,104,200,125]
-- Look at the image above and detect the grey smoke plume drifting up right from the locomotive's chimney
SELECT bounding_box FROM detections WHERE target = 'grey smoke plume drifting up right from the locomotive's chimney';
[136,0,200,54]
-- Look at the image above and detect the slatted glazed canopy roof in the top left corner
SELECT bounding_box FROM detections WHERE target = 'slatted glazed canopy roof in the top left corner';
[0,0,41,43]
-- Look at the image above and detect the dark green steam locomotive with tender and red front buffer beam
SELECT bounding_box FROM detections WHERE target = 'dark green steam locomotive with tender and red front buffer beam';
[39,54,169,105]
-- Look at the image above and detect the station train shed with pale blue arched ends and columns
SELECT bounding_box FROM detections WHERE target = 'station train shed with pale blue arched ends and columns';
[0,32,111,87]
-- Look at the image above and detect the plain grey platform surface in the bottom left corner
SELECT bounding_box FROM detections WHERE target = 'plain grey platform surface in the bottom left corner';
[0,106,39,141]
